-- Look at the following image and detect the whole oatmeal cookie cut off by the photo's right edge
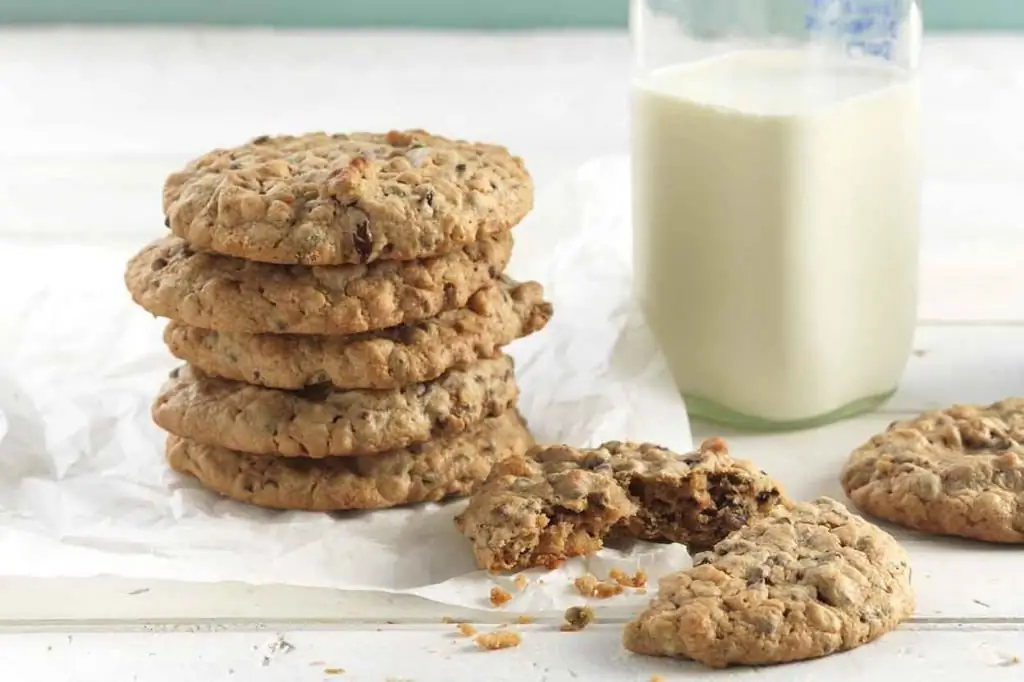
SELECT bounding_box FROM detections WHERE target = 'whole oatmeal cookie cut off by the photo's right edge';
[841,398,1024,543]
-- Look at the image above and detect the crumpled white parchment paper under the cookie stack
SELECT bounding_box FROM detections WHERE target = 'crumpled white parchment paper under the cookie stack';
[0,160,692,613]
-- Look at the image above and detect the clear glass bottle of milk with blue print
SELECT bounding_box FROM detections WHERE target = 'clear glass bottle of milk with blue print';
[631,0,922,430]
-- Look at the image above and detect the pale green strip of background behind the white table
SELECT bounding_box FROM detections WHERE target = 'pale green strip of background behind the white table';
[0,0,1024,31]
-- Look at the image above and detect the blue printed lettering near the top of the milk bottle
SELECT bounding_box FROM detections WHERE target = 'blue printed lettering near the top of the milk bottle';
[804,0,906,59]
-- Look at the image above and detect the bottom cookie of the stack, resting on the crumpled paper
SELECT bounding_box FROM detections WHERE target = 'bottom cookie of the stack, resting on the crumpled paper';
[167,410,534,511]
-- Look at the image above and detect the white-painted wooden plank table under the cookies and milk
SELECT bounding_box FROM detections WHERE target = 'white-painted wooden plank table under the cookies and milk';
[0,26,1024,682]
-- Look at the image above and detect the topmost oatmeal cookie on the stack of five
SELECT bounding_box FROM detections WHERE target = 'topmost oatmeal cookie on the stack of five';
[164,130,534,265]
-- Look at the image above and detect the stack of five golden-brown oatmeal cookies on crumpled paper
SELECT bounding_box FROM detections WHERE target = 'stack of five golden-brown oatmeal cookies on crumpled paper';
[125,131,552,511]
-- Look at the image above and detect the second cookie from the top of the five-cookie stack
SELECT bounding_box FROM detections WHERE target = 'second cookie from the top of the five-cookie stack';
[125,232,512,334]
